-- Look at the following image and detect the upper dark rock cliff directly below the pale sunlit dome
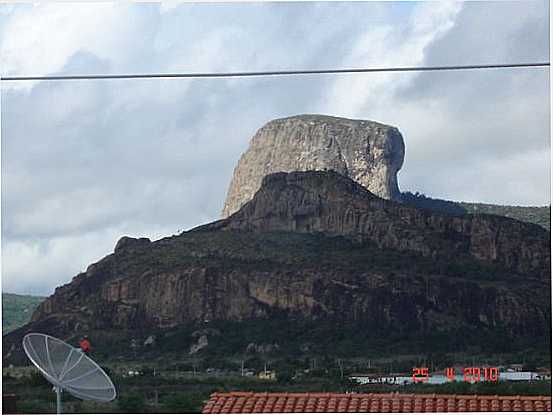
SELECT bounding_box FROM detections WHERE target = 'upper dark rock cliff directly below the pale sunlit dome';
[209,172,551,280]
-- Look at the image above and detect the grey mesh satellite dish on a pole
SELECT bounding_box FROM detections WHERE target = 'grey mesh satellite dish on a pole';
[23,333,116,414]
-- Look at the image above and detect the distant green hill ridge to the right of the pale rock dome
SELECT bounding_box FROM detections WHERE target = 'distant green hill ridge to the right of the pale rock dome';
[402,192,551,230]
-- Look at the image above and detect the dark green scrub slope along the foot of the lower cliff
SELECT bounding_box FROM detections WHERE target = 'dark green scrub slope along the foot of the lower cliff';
[76,316,551,371]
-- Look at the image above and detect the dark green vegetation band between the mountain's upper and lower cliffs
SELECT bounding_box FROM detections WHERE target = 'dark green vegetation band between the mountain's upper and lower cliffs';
[153,231,540,287]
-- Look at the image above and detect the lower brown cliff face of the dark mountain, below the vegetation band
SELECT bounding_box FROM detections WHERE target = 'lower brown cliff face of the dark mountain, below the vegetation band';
[22,247,550,336]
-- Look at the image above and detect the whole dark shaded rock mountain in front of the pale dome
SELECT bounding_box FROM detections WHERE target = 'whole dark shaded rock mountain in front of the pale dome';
[4,171,551,360]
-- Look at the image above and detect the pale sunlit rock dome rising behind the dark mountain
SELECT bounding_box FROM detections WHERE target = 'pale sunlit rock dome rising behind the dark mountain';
[223,115,404,217]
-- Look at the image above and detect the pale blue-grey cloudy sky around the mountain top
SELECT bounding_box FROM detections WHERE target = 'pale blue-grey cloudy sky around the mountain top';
[0,1,551,295]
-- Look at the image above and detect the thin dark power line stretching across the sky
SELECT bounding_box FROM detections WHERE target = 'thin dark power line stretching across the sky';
[0,62,550,81]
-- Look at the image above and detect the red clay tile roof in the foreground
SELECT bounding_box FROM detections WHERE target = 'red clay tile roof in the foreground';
[202,392,551,414]
